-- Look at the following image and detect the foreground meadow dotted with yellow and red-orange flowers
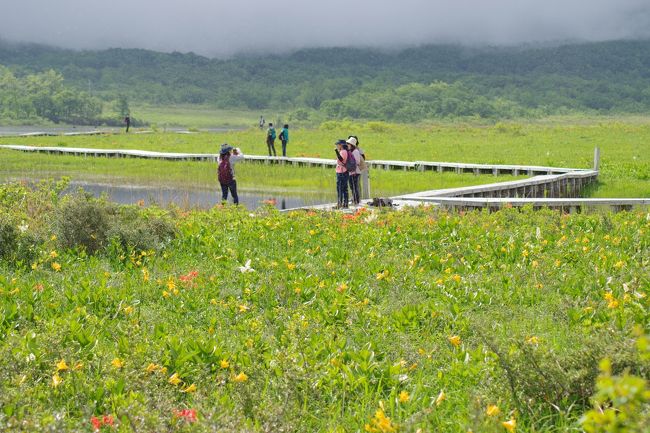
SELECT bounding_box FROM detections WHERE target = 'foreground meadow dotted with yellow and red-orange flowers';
[0,184,650,433]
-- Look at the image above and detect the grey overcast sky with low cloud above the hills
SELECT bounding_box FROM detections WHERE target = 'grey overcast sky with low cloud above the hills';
[0,0,650,56]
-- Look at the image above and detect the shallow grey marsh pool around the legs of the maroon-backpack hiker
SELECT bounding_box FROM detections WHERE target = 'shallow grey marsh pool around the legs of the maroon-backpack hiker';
[64,182,336,209]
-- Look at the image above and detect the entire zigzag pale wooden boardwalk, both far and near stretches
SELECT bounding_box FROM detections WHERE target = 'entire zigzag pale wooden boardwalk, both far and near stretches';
[0,143,636,211]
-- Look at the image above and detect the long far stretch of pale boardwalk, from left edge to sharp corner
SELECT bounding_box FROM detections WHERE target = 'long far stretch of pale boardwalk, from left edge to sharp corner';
[0,144,581,176]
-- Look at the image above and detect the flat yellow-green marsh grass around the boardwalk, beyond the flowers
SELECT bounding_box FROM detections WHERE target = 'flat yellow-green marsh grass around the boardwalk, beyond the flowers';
[0,118,650,197]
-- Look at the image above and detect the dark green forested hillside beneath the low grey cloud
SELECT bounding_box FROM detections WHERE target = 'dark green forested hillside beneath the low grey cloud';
[0,41,650,122]
